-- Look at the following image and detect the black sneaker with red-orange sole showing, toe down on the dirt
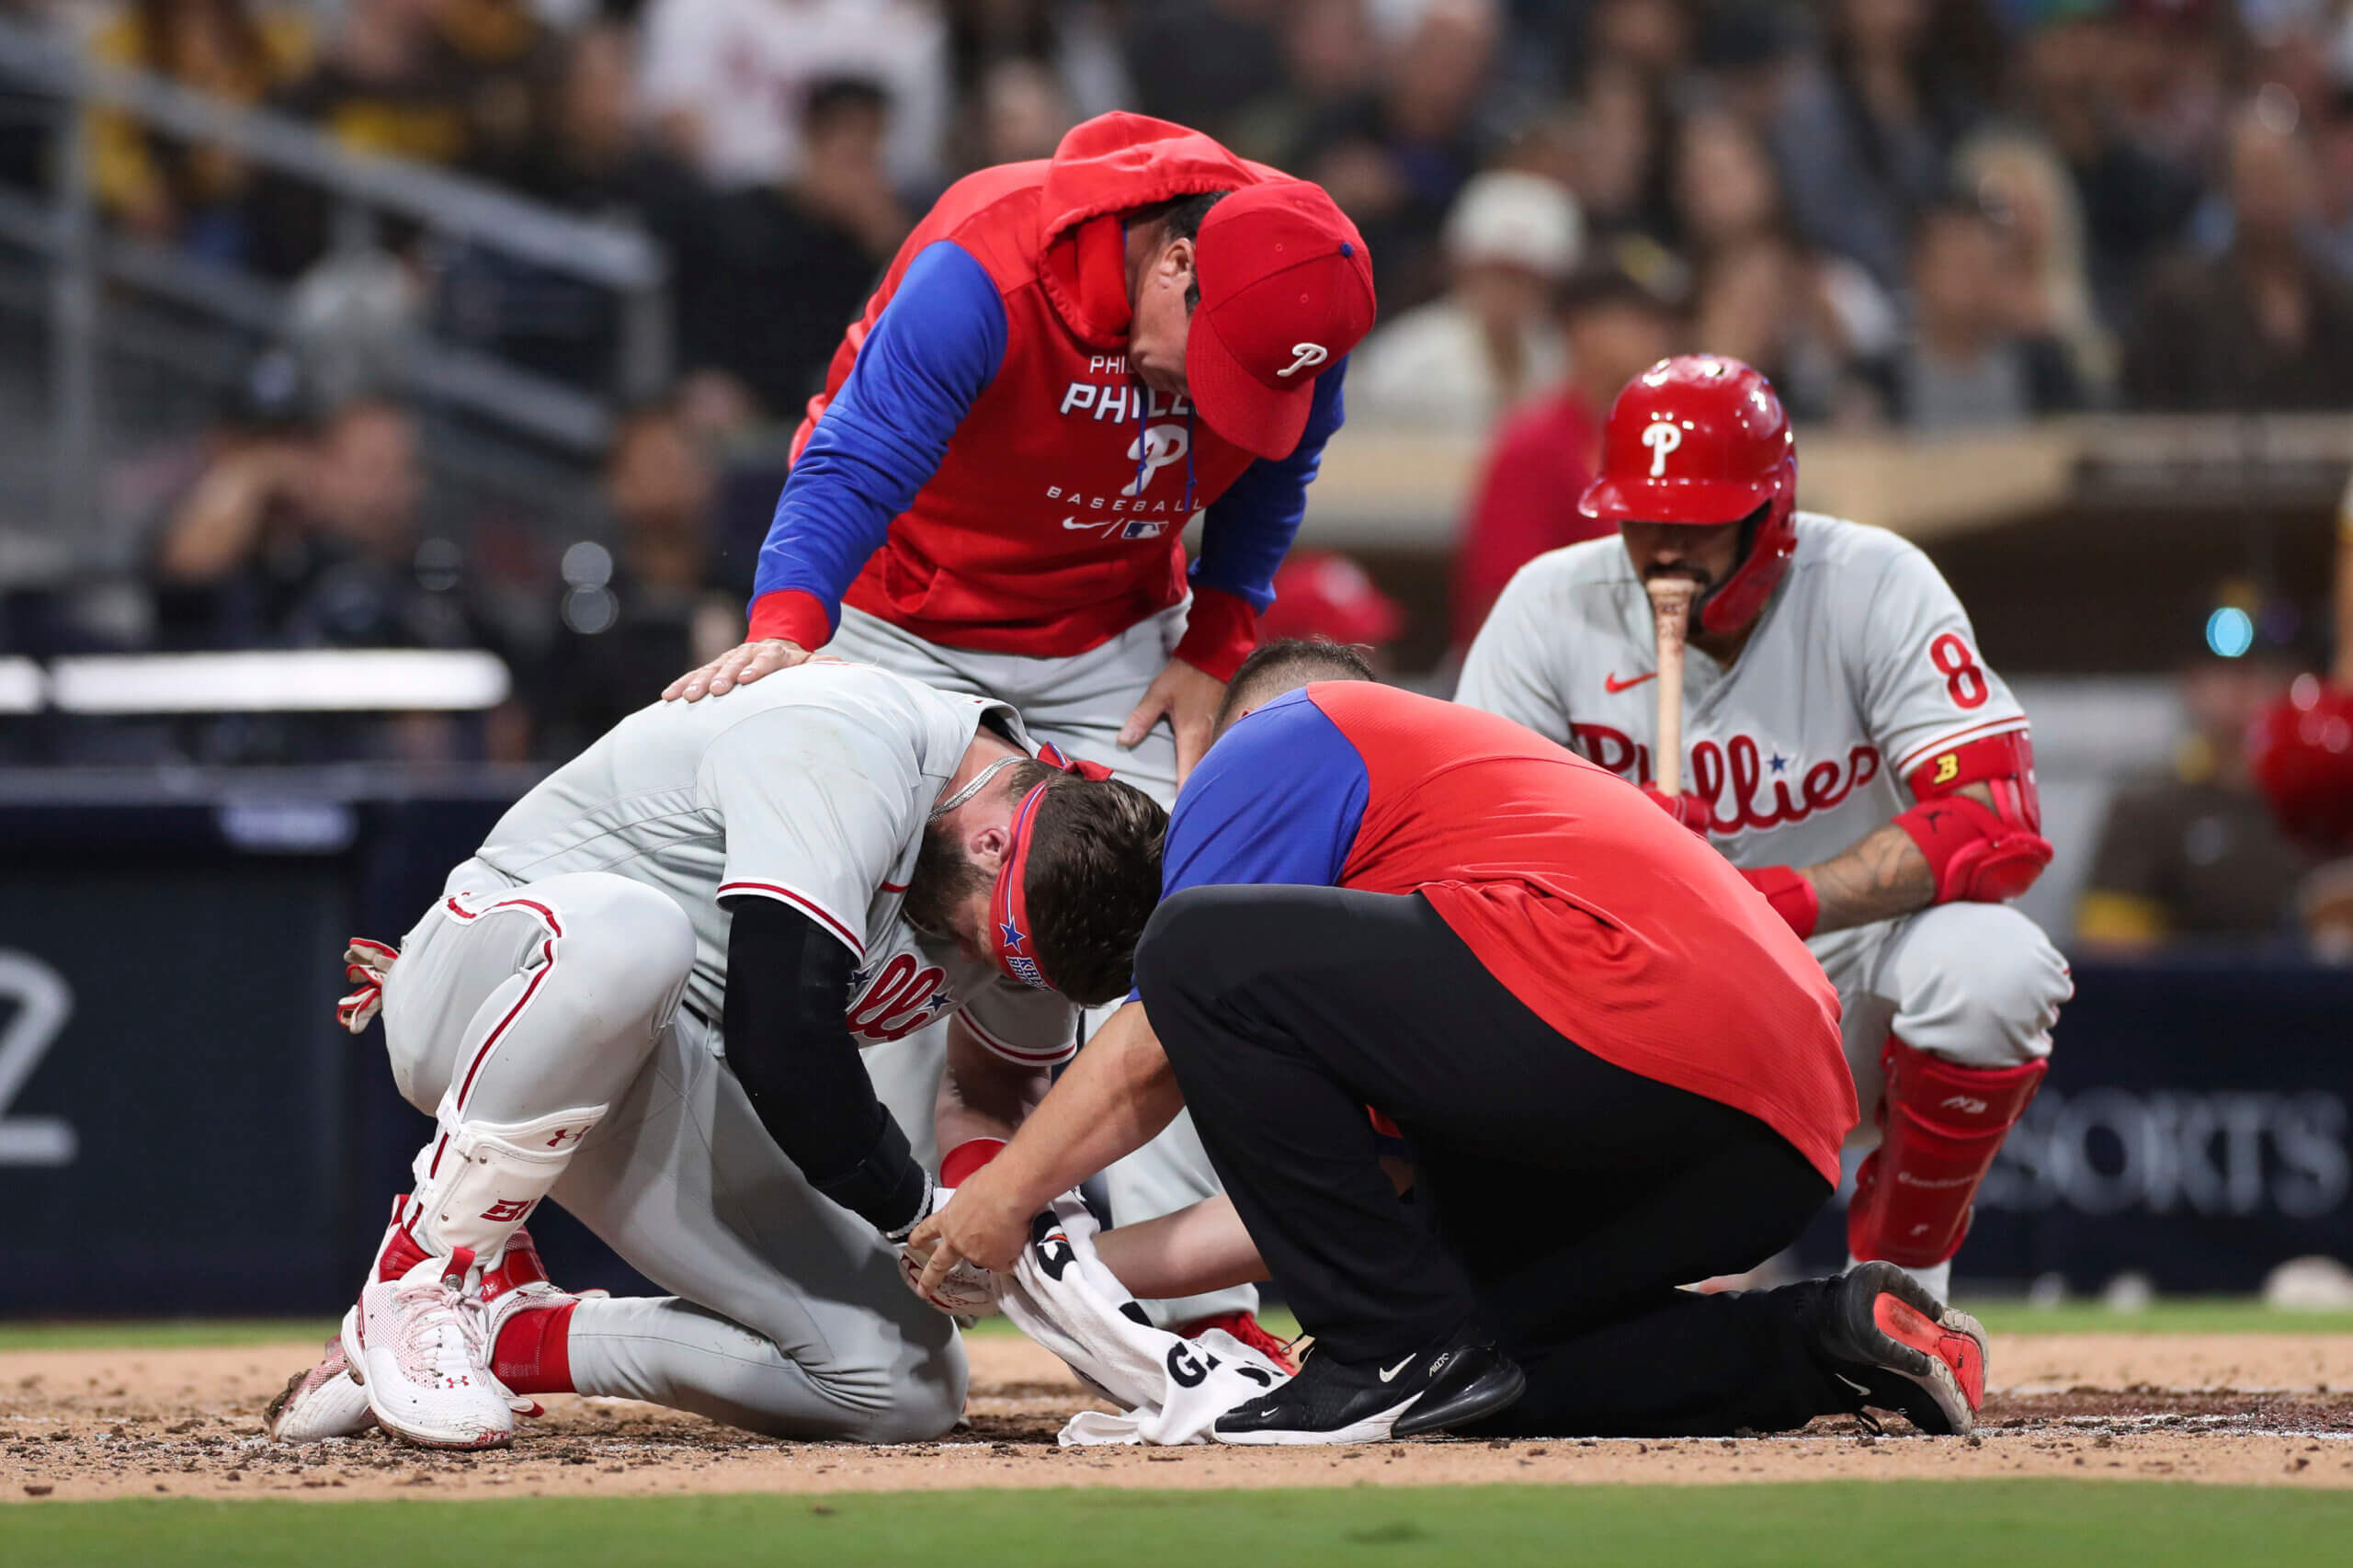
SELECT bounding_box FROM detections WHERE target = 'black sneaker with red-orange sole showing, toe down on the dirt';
[1814,1262,1986,1437]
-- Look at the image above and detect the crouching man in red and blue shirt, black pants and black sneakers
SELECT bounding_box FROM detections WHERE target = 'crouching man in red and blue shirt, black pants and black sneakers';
[911,642,1986,1443]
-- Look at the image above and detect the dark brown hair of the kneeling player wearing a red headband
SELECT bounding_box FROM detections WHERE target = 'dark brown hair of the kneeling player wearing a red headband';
[1007,763,1169,1007]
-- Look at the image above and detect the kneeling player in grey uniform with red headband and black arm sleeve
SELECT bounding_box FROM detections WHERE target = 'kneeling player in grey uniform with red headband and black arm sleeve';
[270,662,1167,1448]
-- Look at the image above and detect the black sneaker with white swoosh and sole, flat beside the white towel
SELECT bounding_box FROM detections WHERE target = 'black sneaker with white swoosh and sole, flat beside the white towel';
[1211,1340,1527,1443]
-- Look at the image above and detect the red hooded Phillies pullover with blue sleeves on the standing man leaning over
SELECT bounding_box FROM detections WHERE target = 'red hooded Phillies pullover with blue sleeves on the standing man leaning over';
[751,116,1346,678]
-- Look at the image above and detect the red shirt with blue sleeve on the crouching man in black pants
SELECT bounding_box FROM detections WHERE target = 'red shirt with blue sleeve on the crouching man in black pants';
[1163,680,1857,1184]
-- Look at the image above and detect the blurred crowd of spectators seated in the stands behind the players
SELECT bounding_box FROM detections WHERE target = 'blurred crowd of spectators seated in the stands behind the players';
[55,0,2353,431]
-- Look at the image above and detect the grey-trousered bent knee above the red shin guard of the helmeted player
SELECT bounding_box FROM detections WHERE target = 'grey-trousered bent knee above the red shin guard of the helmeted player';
[1894,904,2075,1069]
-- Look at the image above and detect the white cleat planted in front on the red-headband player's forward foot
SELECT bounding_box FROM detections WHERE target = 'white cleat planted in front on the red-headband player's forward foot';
[344,1248,516,1448]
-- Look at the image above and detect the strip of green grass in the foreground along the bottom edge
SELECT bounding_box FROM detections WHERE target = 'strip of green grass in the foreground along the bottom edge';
[14,1481,2353,1568]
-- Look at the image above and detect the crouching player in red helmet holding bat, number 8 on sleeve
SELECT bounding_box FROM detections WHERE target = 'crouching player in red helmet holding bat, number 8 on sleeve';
[1457,353,2073,1295]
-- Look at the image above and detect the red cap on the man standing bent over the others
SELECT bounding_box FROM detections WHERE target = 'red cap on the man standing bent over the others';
[1184,179,1374,457]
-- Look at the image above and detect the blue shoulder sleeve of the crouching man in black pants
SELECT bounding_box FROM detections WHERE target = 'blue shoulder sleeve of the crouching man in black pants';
[1160,690,1371,897]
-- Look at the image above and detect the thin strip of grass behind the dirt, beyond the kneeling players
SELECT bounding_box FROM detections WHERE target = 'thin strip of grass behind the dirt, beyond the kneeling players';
[0,1297,2353,1351]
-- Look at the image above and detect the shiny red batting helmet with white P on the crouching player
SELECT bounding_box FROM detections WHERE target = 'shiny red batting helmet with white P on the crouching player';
[1576,353,1798,633]
